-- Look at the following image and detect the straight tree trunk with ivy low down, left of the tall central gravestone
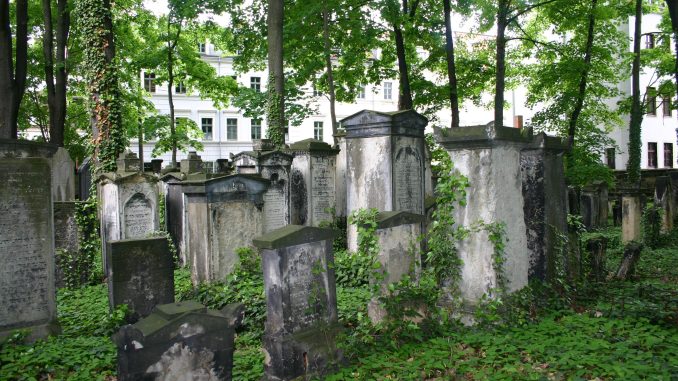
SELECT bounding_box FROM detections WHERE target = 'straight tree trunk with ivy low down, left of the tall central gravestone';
[266,0,285,147]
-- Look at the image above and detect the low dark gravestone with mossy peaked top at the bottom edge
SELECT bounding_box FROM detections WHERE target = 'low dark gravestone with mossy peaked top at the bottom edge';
[112,301,244,381]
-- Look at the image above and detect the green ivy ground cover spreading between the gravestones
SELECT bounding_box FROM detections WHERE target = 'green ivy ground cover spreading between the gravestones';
[0,224,678,380]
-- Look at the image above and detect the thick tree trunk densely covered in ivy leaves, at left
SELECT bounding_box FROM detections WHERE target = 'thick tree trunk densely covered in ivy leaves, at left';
[76,0,127,171]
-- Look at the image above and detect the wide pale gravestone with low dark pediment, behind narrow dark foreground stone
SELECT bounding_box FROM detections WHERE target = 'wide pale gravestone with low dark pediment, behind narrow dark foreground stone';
[182,175,270,284]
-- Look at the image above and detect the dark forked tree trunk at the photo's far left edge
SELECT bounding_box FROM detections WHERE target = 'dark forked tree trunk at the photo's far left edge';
[0,0,28,139]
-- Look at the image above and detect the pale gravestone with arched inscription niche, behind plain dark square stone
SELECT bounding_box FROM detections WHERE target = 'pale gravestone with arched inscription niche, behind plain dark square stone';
[99,152,160,269]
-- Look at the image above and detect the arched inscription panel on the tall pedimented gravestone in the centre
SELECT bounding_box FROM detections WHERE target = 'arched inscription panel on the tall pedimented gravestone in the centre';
[393,147,423,214]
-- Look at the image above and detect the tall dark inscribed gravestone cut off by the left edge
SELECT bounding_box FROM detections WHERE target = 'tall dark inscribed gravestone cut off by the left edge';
[0,139,58,339]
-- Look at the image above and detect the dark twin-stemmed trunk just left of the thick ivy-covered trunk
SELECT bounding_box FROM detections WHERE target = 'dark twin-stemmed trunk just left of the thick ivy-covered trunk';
[42,0,71,147]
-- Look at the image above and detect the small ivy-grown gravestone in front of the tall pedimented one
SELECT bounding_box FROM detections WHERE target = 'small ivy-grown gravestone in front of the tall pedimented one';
[367,211,424,324]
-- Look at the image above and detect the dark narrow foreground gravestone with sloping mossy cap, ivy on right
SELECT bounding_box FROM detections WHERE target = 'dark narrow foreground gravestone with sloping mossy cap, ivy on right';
[253,225,341,380]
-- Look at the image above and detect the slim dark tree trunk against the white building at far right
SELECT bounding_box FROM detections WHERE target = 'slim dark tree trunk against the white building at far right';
[626,0,643,185]
